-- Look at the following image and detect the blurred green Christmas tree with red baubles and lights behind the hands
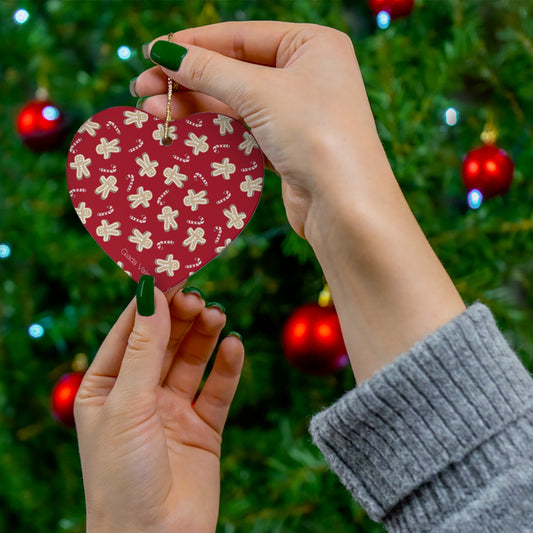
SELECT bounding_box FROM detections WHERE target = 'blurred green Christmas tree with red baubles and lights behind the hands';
[0,0,533,533]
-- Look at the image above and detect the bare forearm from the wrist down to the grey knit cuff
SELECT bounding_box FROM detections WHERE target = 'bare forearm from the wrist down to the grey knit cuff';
[305,143,465,382]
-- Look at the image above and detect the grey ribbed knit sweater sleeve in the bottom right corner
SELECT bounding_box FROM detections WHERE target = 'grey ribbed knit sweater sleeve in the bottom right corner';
[310,303,533,533]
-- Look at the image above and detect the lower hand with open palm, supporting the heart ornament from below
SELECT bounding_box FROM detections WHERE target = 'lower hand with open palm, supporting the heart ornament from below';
[75,278,244,533]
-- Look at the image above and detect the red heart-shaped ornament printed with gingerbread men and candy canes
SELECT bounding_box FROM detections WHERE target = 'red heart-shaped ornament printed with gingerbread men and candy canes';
[67,107,263,291]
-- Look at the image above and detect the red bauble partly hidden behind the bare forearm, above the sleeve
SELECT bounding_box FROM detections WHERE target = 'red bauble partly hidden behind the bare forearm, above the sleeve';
[282,304,348,375]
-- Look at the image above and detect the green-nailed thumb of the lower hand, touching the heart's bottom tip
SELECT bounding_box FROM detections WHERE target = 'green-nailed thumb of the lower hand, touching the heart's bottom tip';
[115,276,170,392]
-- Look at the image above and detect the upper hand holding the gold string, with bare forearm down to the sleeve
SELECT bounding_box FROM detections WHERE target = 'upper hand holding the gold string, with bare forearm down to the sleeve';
[133,22,464,382]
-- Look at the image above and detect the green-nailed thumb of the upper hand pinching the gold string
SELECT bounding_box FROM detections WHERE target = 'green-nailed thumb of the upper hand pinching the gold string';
[149,40,269,118]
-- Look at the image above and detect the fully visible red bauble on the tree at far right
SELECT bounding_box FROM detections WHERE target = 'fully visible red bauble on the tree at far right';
[462,144,514,198]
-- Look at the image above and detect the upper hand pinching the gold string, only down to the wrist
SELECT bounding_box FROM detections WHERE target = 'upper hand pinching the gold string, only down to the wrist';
[134,22,384,237]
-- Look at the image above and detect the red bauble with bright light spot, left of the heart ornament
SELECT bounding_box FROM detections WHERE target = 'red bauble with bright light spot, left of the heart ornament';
[17,99,66,152]
